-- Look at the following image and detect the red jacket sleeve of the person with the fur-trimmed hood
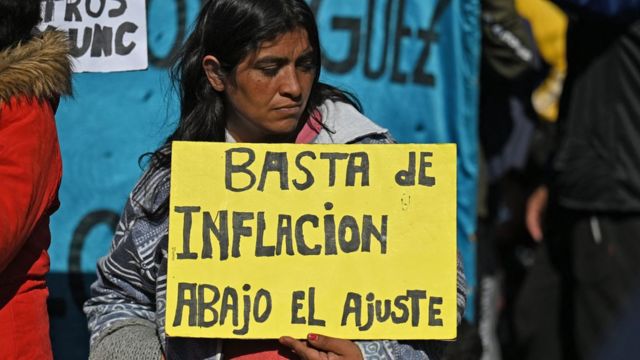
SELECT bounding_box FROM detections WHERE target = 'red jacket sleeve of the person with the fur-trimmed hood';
[0,98,62,272]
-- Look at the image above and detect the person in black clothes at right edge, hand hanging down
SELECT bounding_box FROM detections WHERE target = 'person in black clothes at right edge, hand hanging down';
[527,0,640,359]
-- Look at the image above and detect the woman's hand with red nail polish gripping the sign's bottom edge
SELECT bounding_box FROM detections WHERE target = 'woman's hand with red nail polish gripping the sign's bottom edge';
[279,334,362,360]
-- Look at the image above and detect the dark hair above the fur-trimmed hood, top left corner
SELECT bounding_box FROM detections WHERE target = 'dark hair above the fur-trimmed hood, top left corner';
[0,0,40,51]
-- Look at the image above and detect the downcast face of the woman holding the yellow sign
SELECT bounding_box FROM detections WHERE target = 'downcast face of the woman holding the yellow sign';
[223,28,317,142]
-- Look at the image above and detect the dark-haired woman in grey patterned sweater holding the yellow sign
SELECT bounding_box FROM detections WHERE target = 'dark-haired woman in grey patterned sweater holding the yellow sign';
[85,0,464,359]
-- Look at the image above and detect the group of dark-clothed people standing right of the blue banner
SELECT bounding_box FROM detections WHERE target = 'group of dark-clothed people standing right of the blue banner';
[478,0,640,359]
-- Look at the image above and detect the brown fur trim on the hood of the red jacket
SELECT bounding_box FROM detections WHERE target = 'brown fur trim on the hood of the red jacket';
[0,31,71,102]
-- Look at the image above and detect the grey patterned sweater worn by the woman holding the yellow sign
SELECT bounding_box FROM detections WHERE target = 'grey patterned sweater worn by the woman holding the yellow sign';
[84,102,466,360]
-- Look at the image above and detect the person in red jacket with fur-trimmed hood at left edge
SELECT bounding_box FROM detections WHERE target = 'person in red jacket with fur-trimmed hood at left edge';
[0,0,71,359]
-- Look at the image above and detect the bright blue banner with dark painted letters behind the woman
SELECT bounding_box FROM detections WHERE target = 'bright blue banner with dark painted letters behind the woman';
[49,0,480,359]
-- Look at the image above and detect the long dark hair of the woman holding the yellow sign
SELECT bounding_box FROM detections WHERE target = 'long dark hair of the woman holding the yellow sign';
[142,0,361,219]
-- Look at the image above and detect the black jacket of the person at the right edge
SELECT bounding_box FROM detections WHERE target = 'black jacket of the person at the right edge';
[553,18,640,212]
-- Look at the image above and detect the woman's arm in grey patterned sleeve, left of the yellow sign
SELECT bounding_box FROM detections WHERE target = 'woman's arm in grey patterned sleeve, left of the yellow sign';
[84,180,168,360]
